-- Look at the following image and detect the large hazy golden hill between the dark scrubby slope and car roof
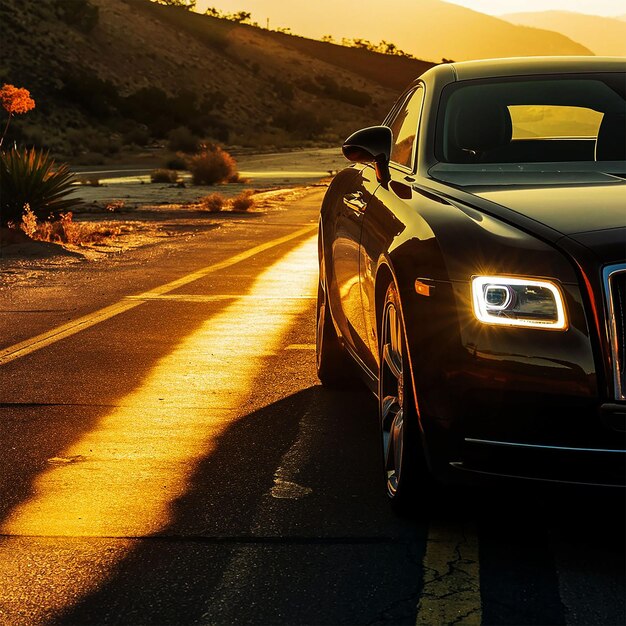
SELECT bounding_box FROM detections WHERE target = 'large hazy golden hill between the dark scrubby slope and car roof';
[198,0,591,62]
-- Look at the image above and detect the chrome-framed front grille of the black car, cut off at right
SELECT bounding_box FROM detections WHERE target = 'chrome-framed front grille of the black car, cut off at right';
[604,263,626,400]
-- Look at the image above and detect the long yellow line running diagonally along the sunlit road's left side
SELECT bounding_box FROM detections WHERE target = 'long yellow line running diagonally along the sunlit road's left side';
[0,226,317,365]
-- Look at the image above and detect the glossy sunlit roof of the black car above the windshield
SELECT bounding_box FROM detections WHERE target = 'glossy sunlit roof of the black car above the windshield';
[423,56,626,82]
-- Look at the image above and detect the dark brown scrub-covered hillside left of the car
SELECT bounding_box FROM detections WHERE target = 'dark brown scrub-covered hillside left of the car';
[0,0,432,162]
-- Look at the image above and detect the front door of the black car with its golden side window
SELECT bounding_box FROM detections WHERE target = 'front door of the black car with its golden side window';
[359,85,424,373]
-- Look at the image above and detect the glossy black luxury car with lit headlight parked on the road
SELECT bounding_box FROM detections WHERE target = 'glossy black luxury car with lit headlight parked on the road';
[317,57,626,504]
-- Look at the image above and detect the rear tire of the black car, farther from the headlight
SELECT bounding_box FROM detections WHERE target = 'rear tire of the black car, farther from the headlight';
[315,281,354,388]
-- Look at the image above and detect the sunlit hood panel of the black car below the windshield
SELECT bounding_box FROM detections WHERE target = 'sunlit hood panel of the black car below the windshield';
[465,182,626,238]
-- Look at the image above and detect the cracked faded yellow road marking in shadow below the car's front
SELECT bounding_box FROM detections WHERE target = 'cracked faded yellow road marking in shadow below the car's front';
[415,524,482,626]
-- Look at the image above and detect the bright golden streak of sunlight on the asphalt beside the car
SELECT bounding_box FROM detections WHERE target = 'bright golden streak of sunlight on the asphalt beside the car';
[0,238,317,623]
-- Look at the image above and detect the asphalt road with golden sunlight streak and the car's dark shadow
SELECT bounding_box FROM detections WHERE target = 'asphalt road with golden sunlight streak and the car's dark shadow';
[0,191,626,625]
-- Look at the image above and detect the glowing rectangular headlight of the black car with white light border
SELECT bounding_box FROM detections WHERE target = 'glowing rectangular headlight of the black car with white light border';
[472,276,567,330]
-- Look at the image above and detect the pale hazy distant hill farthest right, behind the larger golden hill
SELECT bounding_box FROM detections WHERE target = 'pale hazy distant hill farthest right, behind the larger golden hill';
[503,11,626,56]
